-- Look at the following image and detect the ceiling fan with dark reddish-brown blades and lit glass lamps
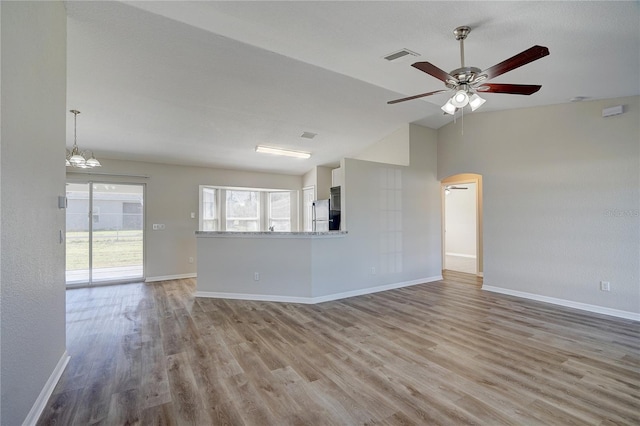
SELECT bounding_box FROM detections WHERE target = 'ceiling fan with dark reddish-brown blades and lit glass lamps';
[387,26,549,115]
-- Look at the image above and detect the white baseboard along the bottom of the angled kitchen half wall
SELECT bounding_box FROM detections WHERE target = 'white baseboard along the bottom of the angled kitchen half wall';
[196,275,442,305]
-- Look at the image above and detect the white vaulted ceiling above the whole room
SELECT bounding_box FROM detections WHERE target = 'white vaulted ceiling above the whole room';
[66,1,640,174]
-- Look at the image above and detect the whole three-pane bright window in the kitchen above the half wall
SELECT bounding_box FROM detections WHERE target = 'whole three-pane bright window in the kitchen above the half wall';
[200,185,298,232]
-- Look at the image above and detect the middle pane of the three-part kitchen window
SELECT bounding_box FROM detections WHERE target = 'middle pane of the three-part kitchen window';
[225,190,260,232]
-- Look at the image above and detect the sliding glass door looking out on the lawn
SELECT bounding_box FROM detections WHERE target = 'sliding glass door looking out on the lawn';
[66,182,144,285]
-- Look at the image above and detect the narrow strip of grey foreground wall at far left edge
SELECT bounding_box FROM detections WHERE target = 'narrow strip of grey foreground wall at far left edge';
[0,2,68,425]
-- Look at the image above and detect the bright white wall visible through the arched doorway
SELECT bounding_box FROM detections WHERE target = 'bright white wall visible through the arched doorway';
[444,183,476,257]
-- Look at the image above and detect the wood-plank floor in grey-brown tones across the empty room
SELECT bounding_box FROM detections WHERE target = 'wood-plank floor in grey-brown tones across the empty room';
[39,272,640,425]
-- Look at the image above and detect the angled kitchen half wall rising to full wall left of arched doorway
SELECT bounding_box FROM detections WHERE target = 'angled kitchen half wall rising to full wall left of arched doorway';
[198,125,442,299]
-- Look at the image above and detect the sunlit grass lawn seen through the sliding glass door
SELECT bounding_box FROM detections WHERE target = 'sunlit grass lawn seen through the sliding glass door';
[66,231,143,271]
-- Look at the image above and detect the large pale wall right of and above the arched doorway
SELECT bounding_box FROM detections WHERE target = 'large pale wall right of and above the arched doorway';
[438,97,640,314]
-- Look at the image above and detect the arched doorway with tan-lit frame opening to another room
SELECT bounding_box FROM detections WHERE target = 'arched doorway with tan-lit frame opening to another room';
[440,173,483,276]
